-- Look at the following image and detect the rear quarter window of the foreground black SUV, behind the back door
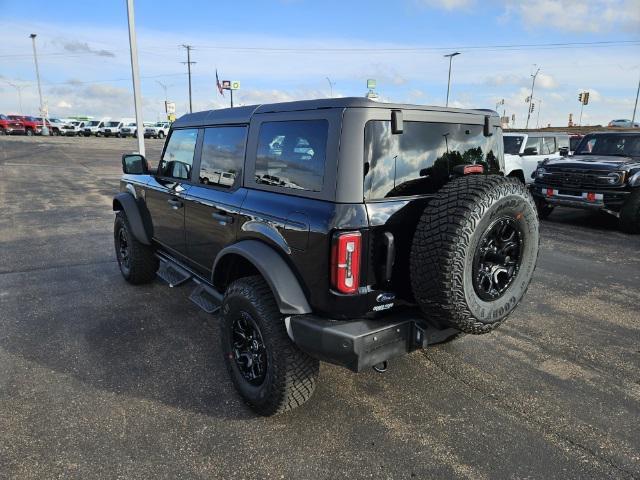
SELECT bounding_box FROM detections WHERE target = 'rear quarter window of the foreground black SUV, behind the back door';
[255,120,329,192]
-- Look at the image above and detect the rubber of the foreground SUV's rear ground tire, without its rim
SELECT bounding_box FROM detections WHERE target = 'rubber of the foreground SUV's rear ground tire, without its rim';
[220,276,320,416]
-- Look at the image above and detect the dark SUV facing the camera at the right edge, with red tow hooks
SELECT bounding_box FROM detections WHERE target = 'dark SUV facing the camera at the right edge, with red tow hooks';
[532,131,640,233]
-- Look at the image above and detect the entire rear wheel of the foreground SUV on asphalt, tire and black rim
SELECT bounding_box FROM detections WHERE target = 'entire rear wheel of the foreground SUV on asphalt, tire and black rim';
[220,276,319,416]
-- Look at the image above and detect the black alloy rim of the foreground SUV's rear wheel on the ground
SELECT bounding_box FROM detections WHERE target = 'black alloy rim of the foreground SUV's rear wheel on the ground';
[232,311,267,385]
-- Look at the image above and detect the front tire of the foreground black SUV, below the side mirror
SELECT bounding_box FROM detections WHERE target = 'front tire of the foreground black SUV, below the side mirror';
[113,211,159,285]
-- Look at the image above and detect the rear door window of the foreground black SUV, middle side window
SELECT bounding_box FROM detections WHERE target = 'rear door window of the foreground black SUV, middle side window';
[198,127,247,188]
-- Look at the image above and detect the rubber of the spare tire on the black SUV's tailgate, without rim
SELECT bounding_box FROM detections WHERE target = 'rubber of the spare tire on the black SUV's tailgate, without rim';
[410,175,539,334]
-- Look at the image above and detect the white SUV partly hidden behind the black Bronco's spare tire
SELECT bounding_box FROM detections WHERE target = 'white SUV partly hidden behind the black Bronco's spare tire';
[503,132,569,184]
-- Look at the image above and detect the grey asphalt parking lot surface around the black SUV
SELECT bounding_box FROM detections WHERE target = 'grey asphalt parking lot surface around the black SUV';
[0,137,640,479]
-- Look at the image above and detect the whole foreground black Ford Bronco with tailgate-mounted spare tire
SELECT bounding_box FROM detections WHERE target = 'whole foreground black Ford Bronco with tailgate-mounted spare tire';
[113,98,538,415]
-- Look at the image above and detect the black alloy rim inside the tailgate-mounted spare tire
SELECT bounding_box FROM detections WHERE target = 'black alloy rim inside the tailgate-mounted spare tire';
[473,217,523,302]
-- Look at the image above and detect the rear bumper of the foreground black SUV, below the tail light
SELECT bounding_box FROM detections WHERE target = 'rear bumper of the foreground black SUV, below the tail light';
[286,313,459,372]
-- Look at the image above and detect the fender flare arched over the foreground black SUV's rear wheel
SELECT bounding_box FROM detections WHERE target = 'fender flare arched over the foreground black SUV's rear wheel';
[212,240,311,315]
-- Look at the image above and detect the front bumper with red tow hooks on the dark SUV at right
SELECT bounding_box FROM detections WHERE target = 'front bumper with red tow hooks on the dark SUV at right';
[531,183,630,211]
